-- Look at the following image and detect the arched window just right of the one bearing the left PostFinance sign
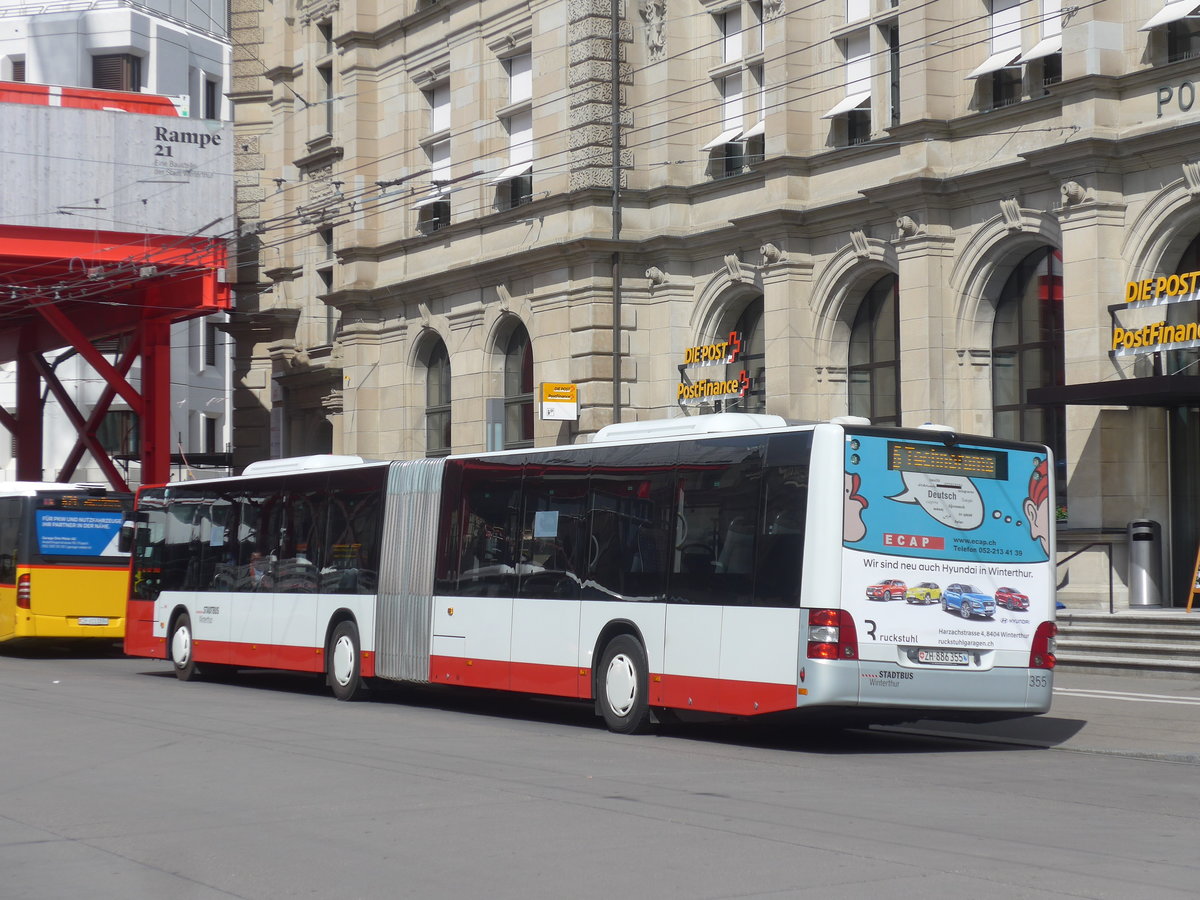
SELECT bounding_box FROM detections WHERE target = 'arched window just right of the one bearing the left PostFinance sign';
[846,275,900,425]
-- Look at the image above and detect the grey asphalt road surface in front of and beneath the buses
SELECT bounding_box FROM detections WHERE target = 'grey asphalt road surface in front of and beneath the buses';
[0,652,1200,900]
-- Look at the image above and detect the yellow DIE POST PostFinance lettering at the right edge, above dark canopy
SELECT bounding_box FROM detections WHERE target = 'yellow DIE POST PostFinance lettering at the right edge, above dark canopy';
[1109,271,1200,356]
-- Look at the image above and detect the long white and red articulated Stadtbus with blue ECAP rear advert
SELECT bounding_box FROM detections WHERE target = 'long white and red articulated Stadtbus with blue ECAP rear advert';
[125,413,1056,733]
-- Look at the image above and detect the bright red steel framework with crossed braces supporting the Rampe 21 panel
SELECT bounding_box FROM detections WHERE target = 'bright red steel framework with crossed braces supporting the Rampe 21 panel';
[0,83,230,491]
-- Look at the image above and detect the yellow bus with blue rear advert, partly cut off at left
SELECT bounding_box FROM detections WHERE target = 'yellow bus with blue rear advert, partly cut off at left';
[0,481,133,641]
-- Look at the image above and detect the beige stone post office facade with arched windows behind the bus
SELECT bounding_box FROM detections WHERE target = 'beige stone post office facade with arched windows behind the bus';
[230,0,1200,605]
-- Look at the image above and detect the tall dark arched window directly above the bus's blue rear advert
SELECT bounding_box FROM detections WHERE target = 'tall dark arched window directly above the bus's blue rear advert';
[991,247,1067,468]
